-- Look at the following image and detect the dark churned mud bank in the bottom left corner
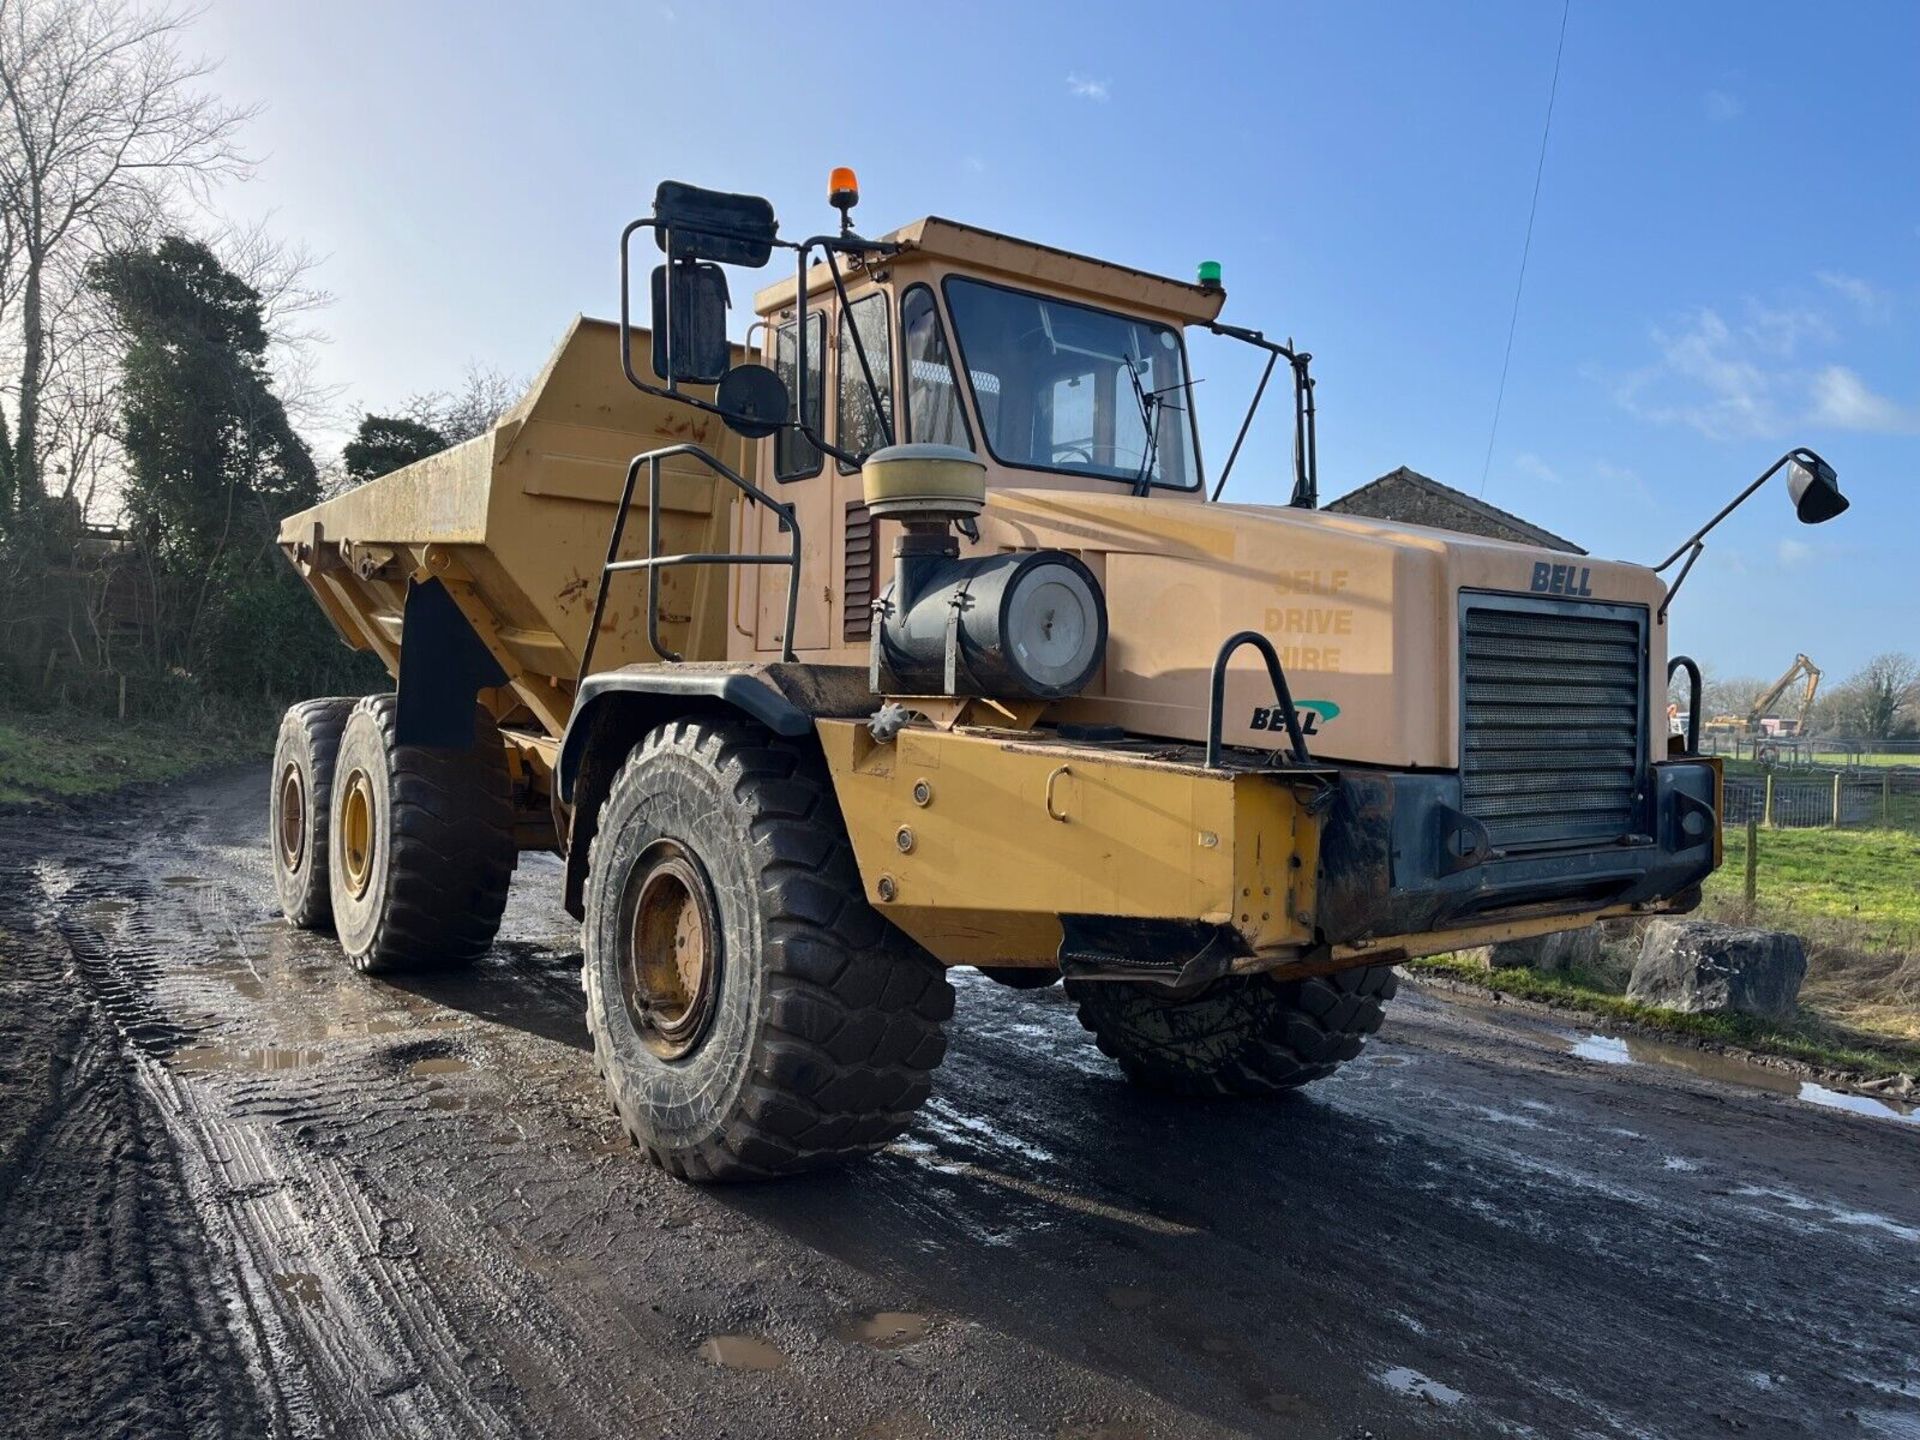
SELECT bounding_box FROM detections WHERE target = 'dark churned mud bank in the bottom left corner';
[0,864,275,1440]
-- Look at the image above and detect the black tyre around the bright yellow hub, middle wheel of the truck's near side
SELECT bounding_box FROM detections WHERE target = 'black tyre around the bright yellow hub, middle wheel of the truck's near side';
[328,695,518,973]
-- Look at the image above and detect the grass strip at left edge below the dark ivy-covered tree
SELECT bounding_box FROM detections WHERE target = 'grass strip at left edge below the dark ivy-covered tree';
[0,710,273,806]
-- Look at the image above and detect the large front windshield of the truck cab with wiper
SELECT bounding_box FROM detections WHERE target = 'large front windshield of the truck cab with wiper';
[945,276,1200,493]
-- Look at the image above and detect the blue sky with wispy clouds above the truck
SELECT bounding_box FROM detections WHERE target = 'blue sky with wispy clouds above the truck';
[194,0,1920,676]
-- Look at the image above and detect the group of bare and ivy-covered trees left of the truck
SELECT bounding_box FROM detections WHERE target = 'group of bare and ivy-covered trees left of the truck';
[0,0,515,718]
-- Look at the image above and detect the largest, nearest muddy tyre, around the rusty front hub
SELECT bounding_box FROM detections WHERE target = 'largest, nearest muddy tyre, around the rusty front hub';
[582,718,954,1181]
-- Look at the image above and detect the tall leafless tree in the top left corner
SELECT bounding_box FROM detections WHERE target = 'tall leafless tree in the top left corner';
[0,0,252,507]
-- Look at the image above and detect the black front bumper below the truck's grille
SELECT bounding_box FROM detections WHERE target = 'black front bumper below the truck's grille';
[1317,760,1720,945]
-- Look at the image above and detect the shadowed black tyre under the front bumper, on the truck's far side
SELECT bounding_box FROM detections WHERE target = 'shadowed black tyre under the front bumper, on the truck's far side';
[1068,966,1398,1096]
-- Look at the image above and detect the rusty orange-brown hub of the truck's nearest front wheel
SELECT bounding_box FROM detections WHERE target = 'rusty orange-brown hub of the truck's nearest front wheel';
[620,839,720,1060]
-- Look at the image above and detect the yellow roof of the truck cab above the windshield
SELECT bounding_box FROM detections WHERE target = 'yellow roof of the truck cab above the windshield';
[753,215,1227,324]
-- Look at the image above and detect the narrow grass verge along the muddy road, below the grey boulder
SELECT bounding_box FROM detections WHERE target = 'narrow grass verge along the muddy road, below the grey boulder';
[1407,954,1920,1079]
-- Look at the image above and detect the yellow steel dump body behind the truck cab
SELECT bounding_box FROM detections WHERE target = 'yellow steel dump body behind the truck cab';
[280,317,756,741]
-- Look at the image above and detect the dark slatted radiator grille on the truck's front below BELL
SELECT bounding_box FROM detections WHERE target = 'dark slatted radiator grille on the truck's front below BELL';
[1459,595,1647,849]
